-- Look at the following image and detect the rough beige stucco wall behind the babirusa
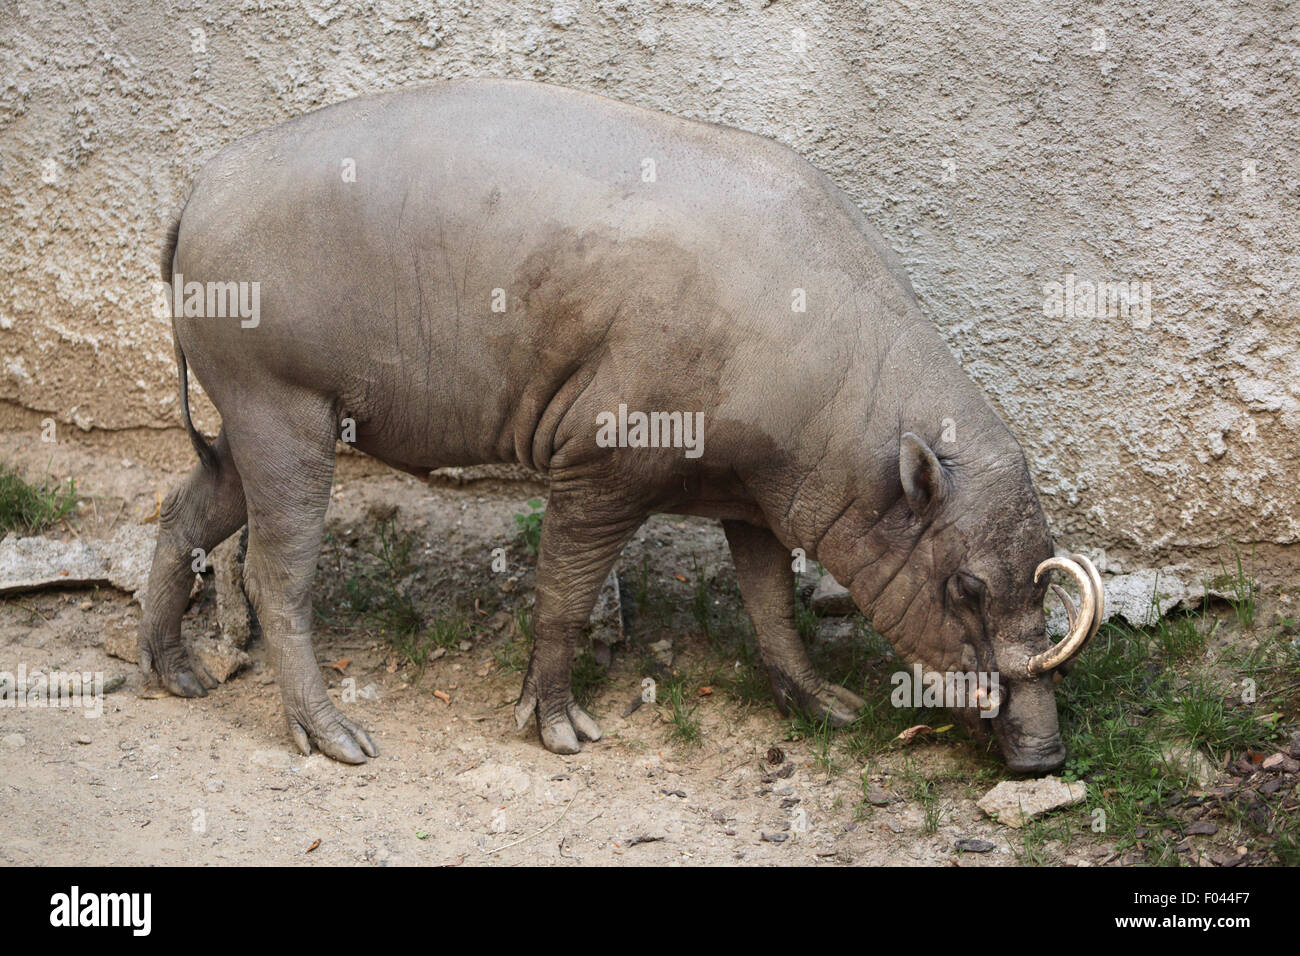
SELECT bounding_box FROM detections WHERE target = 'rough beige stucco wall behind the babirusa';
[0,0,1300,581]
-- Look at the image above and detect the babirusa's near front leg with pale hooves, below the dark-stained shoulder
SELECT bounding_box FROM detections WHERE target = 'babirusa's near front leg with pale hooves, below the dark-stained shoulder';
[515,483,645,753]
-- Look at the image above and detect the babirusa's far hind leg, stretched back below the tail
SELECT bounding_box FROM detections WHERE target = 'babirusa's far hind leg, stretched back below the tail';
[138,431,244,697]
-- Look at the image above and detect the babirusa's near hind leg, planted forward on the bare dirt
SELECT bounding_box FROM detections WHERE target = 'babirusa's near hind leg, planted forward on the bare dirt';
[231,393,380,763]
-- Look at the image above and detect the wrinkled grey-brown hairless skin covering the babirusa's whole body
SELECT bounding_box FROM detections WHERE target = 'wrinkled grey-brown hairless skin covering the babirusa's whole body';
[140,81,1063,771]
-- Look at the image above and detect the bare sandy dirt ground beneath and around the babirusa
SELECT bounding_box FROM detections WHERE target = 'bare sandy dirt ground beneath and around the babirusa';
[0,432,1122,866]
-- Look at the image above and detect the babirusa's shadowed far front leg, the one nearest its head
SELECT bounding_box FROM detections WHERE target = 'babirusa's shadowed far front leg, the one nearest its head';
[723,522,866,727]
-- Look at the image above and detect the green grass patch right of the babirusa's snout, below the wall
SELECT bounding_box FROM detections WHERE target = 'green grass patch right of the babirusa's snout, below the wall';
[1055,563,1297,865]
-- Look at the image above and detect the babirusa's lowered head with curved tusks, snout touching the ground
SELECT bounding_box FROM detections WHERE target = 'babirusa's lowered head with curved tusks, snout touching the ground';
[854,432,1102,774]
